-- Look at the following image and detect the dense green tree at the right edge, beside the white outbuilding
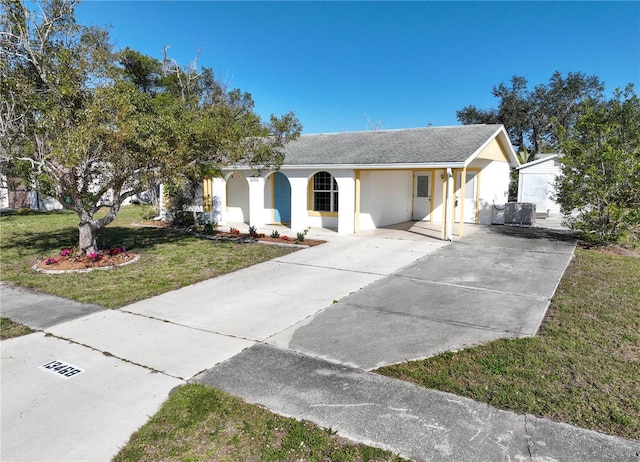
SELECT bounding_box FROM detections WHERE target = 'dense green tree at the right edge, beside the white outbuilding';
[556,85,640,244]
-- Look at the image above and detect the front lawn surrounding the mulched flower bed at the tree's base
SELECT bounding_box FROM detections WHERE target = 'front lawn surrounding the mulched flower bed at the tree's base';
[0,206,291,308]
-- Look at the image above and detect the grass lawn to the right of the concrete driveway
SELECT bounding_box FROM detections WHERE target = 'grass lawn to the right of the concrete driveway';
[378,248,640,440]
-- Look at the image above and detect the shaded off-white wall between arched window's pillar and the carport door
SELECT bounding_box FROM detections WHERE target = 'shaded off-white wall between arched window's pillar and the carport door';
[360,170,413,230]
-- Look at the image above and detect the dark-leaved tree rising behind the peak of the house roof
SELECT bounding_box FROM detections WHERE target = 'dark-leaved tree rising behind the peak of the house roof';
[456,71,604,153]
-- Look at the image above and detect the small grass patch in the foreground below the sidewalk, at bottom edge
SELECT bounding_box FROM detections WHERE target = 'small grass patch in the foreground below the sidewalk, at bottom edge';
[114,384,405,462]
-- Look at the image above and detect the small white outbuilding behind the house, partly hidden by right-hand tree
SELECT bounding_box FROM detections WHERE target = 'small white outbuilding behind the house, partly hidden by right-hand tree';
[518,154,562,217]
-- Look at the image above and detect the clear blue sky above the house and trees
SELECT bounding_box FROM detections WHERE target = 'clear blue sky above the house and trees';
[76,1,640,133]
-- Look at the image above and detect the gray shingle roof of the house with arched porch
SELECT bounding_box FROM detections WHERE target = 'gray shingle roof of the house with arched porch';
[283,125,500,166]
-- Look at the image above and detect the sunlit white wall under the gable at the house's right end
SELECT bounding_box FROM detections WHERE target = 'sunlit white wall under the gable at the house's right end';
[469,159,510,225]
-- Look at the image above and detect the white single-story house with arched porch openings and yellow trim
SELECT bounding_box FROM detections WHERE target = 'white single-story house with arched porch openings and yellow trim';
[203,125,519,239]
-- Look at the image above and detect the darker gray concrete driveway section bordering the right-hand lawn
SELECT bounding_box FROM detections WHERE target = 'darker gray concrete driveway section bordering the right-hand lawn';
[268,226,575,370]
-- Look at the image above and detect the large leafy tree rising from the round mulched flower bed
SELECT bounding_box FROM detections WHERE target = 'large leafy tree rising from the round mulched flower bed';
[0,0,301,252]
